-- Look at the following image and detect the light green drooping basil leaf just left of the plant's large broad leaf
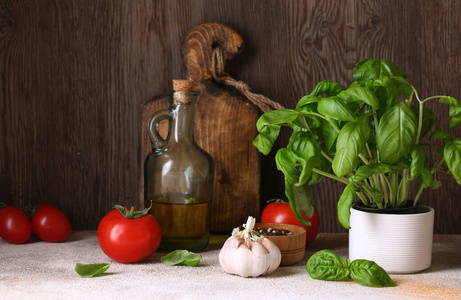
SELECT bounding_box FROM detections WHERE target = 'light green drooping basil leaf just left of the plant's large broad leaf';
[332,116,371,177]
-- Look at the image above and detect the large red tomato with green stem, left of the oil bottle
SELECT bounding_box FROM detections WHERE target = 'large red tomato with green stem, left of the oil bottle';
[97,209,162,263]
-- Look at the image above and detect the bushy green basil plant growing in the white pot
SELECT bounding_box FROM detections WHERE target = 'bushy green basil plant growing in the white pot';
[253,59,461,229]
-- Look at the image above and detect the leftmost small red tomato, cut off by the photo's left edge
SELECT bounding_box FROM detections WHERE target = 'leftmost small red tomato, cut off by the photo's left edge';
[0,206,32,244]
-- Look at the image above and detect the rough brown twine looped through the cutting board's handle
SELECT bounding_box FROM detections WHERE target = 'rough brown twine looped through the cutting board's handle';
[211,47,285,112]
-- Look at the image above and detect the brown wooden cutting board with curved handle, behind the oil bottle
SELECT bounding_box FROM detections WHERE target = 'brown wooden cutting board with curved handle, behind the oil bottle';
[139,23,261,234]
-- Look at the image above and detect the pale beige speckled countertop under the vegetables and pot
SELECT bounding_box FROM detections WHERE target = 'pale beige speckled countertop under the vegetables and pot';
[0,231,461,300]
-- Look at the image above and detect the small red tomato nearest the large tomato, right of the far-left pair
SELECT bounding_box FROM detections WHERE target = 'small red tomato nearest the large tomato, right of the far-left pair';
[32,204,72,243]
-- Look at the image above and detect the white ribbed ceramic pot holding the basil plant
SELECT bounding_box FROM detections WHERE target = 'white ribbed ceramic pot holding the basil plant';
[349,206,434,273]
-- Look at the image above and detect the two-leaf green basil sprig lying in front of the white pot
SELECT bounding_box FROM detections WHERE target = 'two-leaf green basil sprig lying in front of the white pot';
[306,250,395,287]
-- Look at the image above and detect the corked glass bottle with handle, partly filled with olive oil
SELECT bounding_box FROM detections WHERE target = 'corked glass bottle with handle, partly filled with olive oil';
[144,80,214,252]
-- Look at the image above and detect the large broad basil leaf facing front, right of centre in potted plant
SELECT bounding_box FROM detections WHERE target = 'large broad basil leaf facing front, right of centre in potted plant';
[376,103,417,164]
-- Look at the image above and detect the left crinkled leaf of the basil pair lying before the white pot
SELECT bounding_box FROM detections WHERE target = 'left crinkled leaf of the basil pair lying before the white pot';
[306,250,350,281]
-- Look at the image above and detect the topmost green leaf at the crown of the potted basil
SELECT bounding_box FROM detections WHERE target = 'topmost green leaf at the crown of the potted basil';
[352,58,407,83]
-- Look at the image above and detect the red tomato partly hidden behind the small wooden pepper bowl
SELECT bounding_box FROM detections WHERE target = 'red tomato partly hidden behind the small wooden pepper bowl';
[261,202,320,246]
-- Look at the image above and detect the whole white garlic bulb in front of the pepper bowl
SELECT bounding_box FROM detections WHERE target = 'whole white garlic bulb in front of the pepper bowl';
[219,217,282,277]
